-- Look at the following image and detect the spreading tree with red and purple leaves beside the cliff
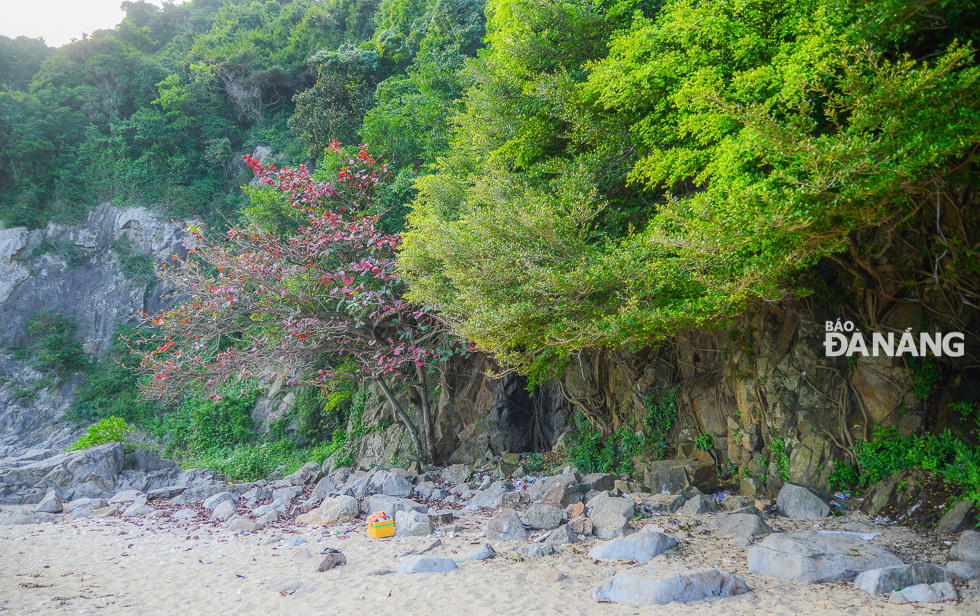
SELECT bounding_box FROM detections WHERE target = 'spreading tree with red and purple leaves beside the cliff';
[140,142,460,462]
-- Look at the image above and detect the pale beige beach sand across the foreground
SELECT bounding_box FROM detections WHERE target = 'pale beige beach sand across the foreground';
[0,507,980,616]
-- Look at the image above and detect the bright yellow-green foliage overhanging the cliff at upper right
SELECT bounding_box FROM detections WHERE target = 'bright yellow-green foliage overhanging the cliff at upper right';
[402,0,980,378]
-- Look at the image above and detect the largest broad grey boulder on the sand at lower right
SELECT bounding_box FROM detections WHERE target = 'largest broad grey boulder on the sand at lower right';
[748,531,902,584]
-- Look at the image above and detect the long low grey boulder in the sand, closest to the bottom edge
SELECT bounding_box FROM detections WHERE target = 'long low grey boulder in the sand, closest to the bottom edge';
[589,567,748,605]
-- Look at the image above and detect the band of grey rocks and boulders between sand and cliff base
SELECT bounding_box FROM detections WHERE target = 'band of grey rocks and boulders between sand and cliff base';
[0,444,980,613]
